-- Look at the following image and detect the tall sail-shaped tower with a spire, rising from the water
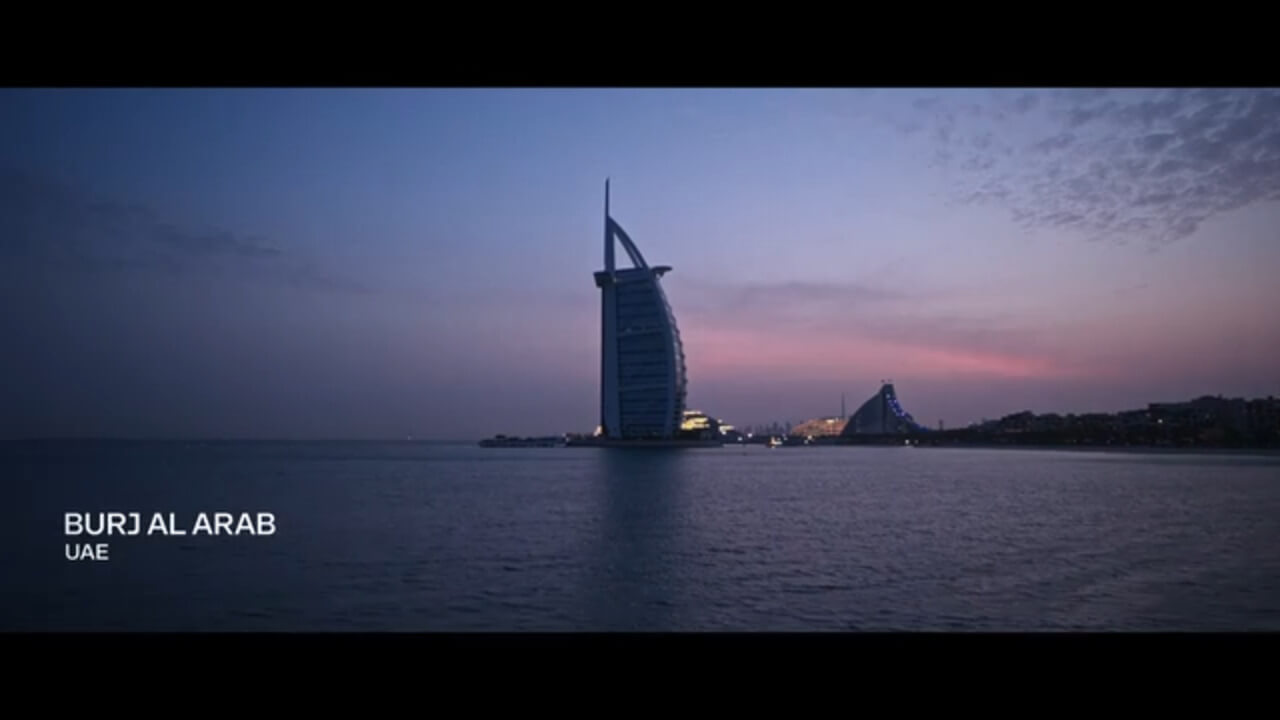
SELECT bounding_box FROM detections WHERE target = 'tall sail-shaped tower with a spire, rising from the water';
[595,179,687,439]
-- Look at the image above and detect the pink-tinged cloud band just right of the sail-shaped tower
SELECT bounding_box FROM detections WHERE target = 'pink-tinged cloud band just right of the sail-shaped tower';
[678,275,1075,377]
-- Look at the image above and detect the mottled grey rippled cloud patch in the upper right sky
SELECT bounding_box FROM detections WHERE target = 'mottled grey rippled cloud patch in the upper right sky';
[893,90,1280,246]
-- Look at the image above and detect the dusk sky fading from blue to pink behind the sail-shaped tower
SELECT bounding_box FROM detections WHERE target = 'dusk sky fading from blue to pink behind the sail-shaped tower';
[0,88,1280,439]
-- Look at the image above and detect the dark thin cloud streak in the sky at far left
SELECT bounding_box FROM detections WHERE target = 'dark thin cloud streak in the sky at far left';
[0,169,371,293]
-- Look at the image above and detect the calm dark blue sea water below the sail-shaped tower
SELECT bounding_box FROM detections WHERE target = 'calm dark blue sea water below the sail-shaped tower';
[0,442,1280,630]
